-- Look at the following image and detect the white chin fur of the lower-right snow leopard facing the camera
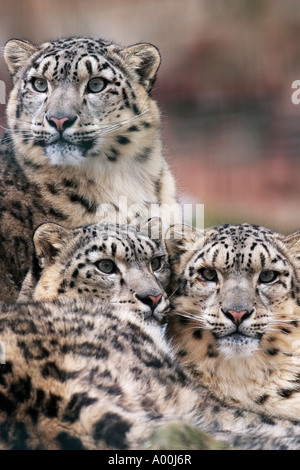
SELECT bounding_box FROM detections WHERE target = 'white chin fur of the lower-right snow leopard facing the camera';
[218,335,260,358]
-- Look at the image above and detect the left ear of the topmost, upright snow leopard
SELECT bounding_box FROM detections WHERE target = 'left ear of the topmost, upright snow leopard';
[4,39,37,75]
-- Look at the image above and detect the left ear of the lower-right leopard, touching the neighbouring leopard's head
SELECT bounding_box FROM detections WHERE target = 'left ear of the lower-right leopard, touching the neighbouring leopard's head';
[165,224,203,262]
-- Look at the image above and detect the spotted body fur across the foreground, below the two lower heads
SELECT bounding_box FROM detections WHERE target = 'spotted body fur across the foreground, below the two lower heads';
[4,298,300,450]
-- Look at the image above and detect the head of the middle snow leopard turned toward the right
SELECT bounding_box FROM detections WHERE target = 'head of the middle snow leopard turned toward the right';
[18,218,170,320]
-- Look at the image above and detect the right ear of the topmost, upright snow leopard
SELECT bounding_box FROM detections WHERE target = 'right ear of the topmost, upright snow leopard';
[120,43,161,92]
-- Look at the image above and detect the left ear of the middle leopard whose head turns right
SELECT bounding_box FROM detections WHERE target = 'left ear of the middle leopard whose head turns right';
[33,223,71,268]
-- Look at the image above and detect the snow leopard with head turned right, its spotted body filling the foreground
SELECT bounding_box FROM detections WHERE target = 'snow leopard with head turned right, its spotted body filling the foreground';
[0,222,300,449]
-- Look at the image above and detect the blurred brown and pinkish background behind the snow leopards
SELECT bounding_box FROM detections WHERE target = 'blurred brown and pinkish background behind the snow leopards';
[0,0,300,233]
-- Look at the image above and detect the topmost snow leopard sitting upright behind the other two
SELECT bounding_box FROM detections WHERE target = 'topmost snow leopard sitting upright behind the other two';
[0,37,180,301]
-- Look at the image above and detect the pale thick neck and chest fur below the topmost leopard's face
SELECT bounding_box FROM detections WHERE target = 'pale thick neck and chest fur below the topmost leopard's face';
[7,119,169,226]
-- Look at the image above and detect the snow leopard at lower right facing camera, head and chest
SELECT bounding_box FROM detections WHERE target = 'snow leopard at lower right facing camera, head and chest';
[167,224,300,419]
